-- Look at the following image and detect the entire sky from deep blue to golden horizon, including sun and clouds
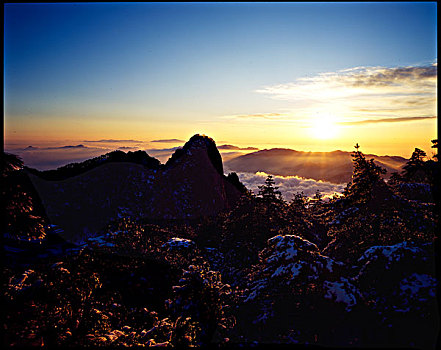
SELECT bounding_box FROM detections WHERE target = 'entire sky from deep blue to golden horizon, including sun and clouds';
[4,2,437,158]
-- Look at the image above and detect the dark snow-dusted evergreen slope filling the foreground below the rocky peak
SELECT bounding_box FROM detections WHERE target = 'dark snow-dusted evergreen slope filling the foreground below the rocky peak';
[2,142,440,350]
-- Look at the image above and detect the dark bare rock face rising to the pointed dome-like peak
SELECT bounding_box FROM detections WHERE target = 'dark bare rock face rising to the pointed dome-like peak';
[28,135,241,241]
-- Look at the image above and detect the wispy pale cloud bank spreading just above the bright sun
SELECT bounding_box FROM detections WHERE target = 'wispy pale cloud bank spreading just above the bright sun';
[256,63,437,124]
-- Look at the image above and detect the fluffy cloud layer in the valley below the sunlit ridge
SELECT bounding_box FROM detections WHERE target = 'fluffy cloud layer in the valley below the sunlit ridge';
[229,172,346,201]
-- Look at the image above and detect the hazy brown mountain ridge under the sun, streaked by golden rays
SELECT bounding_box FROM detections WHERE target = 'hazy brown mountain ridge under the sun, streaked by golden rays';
[225,148,407,183]
